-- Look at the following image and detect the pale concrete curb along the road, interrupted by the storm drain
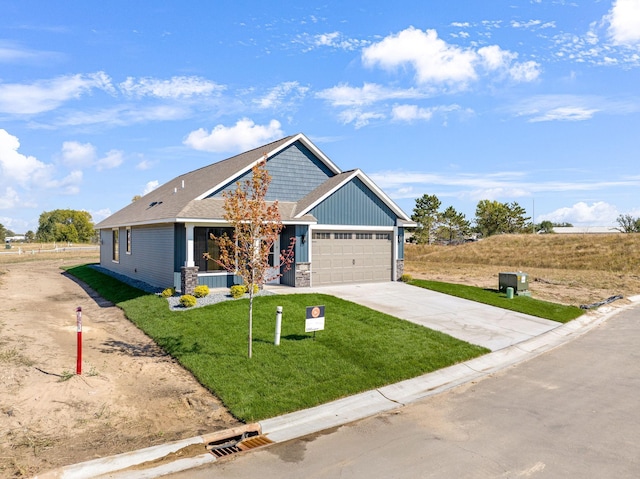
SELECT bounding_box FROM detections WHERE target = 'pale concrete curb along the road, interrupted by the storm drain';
[34,302,640,479]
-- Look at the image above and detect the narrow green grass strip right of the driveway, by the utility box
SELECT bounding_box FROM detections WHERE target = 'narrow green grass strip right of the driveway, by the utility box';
[409,279,584,323]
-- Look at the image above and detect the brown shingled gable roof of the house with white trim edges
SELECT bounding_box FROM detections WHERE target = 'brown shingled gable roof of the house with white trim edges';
[95,133,410,229]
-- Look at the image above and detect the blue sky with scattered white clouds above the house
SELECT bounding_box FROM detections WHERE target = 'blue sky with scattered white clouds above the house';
[0,0,640,234]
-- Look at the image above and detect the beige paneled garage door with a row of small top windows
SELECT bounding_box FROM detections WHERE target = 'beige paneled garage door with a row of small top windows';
[311,231,393,286]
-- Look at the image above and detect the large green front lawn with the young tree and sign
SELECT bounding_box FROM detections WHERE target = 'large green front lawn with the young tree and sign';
[67,265,488,421]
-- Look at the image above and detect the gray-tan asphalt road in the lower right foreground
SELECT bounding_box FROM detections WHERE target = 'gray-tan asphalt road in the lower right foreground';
[171,306,640,479]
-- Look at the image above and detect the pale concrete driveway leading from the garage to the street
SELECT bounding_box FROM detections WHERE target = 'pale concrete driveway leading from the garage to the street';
[268,282,560,351]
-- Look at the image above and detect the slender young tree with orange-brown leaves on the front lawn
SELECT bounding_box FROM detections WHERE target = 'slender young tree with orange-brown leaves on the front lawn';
[204,158,295,358]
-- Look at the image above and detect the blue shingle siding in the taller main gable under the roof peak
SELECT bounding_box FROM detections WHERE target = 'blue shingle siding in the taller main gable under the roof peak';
[211,141,334,201]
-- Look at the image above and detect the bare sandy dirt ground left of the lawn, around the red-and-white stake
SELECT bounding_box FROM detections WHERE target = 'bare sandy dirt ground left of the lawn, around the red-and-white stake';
[0,259,239,478]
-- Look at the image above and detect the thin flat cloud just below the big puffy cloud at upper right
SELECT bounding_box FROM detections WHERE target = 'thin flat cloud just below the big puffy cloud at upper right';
[316,83,428,107]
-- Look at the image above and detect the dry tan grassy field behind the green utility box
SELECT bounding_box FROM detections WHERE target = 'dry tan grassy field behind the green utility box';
[405,234,640,306]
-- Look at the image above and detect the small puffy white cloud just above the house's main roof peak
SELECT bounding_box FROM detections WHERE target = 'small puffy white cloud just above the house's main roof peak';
[184,118,283,152]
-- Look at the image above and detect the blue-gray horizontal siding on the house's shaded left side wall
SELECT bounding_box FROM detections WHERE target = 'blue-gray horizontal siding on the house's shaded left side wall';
[100,224,174,288]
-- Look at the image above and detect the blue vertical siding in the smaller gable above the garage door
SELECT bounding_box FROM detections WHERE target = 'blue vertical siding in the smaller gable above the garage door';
[310,178,396,226]
